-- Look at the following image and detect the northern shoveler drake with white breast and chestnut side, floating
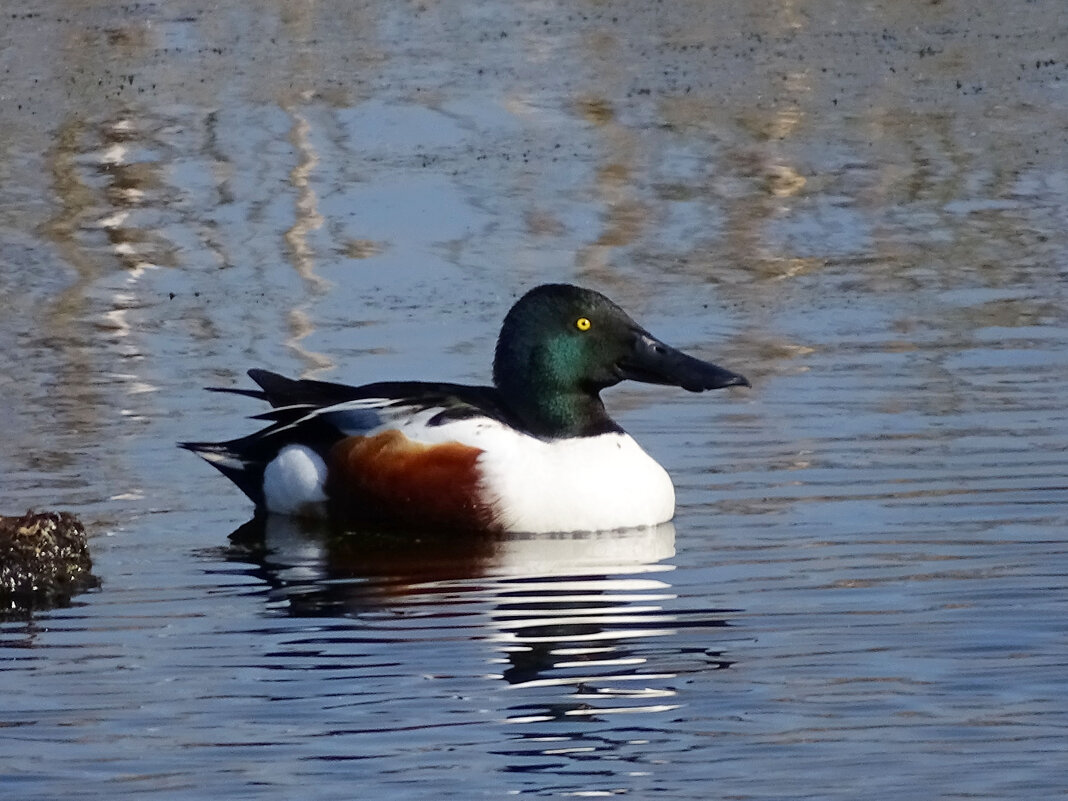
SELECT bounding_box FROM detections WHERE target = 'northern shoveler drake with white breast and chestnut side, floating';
[180,284,749,533]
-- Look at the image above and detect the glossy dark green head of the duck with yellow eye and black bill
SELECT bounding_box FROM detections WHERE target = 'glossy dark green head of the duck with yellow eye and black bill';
[493,284,749,438]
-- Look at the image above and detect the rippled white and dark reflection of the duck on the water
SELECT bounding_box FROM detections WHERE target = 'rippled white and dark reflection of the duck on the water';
[231,517,729,723]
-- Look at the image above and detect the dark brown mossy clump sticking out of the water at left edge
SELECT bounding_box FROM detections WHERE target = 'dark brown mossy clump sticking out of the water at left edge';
[0,512,99,617]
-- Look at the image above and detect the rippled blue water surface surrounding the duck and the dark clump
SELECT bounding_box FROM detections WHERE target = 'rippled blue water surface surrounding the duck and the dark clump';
[0,0,1068,800]
